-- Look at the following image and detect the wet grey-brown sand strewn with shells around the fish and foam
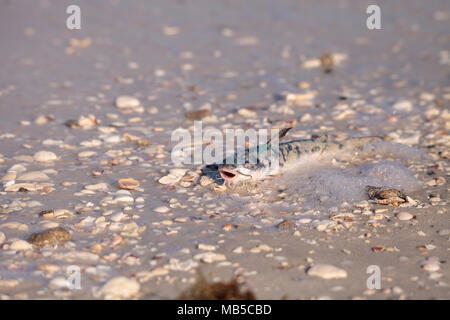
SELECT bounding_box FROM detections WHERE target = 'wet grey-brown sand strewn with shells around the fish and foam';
[0,0,450,299]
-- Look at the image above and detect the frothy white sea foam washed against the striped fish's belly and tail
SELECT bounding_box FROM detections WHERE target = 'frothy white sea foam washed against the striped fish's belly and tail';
[221,141,428,219]
